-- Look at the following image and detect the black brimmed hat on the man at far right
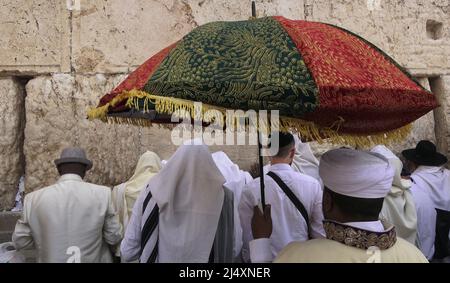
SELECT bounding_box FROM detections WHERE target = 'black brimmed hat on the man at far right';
[402,140,448,166]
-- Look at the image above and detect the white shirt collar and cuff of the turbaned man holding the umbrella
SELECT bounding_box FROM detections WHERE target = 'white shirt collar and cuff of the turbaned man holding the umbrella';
[250,221,385,263]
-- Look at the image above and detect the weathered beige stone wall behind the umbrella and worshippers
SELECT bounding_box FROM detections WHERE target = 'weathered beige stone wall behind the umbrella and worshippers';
[0,0,450,211]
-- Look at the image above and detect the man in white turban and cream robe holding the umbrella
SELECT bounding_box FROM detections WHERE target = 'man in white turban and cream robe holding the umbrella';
[250,148,428,263]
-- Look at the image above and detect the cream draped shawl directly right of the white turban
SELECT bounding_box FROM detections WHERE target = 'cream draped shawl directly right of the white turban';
[372,145,417,245]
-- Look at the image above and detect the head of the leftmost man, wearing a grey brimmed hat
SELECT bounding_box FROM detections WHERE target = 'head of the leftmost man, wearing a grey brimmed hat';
[55,147,92,178]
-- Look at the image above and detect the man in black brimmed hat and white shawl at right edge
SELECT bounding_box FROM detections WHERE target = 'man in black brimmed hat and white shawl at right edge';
[402,140,450,260]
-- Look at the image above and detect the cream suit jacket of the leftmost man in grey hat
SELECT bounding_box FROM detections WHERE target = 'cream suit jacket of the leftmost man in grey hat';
[13,174,122,263]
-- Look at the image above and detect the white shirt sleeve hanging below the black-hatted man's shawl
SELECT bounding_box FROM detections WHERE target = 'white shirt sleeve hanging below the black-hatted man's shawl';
[410,181,436,260]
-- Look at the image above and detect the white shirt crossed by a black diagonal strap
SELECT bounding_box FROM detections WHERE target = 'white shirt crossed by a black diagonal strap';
[239,164,325,261]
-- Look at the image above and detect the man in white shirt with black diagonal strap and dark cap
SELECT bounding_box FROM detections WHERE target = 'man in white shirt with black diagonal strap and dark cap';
[239,133,325,261]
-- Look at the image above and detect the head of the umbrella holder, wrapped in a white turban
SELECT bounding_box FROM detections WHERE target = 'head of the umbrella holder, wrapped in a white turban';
[319,148,395,222]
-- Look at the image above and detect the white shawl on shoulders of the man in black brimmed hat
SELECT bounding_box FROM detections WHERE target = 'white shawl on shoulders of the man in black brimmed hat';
[411,166,450,211]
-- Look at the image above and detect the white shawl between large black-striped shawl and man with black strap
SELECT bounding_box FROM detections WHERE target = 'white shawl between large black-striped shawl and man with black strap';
[212,151,253,258]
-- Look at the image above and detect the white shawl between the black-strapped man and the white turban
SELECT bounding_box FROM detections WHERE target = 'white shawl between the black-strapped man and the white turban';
[291,135,323,187]
